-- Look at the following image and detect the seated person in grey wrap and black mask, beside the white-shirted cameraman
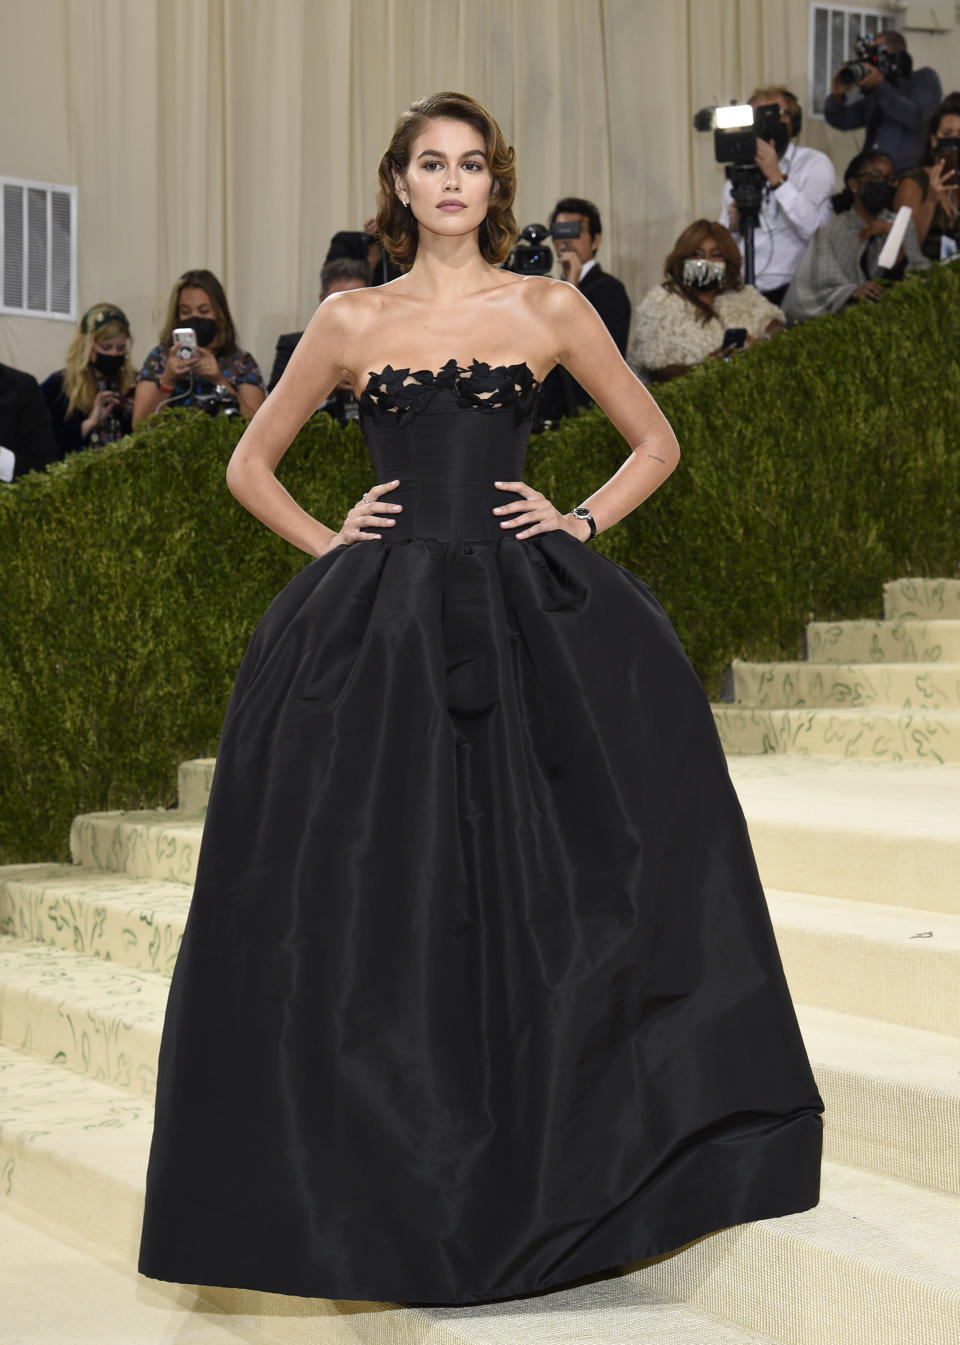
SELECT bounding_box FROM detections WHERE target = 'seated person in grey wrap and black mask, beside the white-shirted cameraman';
[784,149,930,323]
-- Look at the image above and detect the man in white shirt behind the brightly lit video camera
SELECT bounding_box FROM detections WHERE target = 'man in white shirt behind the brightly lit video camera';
[719,85,836,304]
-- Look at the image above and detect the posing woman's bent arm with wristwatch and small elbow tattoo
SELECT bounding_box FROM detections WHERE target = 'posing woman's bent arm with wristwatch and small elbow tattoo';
[499,284,680,541]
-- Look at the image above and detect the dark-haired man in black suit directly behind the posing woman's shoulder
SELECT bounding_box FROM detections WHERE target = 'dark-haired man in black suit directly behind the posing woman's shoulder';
[539,196,631,421]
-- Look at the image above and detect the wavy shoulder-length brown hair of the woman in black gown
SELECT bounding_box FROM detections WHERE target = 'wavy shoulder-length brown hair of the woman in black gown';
[376,93,516,268]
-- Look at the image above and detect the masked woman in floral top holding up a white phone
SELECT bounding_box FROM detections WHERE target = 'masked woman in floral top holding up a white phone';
[133,269,266,425]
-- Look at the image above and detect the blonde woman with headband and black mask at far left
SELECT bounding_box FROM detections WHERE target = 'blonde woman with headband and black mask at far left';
[40,303,136,457]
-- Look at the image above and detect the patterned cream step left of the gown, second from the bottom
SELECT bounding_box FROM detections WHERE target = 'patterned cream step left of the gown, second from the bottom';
[0,937,169,1098]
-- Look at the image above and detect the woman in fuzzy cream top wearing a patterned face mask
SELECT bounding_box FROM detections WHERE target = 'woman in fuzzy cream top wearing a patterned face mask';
[628,219,784,382]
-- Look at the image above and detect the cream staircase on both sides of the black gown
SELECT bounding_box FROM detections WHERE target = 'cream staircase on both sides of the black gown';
[0,584,960,1345]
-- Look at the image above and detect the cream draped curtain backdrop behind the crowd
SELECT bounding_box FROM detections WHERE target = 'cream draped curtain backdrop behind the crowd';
[0,0,941,377]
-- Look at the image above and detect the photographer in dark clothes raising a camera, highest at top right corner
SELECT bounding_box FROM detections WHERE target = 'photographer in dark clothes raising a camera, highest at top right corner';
[823,31,943,174]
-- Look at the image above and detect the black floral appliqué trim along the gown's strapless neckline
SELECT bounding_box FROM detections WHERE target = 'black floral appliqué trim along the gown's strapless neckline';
[360,359,541,425]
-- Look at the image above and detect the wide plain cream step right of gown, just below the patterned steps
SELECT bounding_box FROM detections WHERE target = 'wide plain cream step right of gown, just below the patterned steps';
[727,755,960,915]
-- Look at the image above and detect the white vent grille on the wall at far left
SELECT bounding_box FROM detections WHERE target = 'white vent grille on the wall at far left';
[0,178,77,321]
